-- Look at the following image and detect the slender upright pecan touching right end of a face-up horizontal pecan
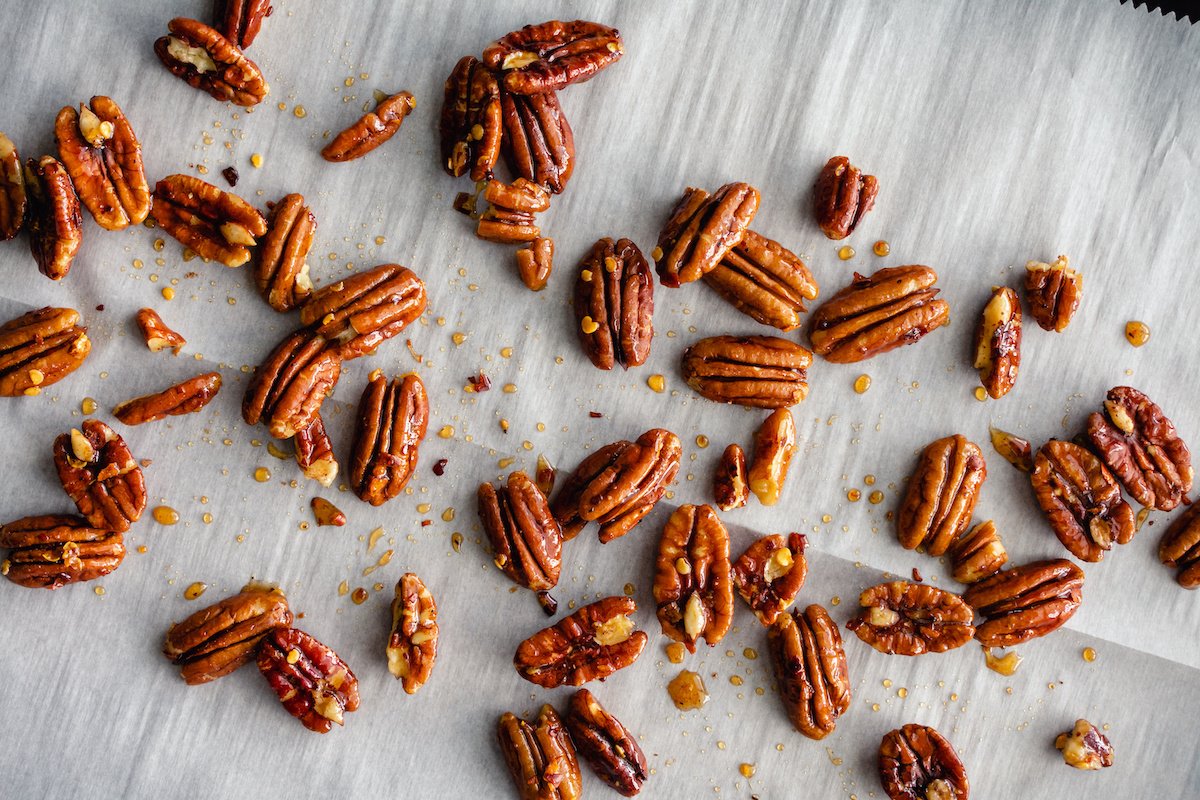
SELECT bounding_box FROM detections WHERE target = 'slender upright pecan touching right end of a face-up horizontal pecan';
[254,193,317,312]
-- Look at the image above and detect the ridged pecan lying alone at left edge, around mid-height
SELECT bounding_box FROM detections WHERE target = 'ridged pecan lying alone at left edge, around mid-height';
[0,306,91,397]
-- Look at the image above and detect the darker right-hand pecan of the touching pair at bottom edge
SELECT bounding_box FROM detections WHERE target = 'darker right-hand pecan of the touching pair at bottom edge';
[564,688,650,798]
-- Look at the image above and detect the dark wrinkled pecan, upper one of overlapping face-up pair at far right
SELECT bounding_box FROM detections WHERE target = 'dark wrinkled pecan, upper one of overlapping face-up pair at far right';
[1087,386,1193,511]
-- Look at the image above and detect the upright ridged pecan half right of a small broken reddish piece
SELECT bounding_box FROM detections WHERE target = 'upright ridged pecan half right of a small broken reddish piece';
[349,369,430,506]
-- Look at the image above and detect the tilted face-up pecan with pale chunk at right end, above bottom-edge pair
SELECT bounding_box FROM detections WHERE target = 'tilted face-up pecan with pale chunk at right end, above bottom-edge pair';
[512,596,648,688]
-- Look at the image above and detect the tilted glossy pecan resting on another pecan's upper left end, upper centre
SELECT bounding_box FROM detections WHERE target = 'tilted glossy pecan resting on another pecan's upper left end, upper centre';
[650,184,758,288]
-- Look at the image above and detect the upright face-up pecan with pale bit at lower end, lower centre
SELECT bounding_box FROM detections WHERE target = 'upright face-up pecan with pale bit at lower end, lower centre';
[654,505,733,652]
